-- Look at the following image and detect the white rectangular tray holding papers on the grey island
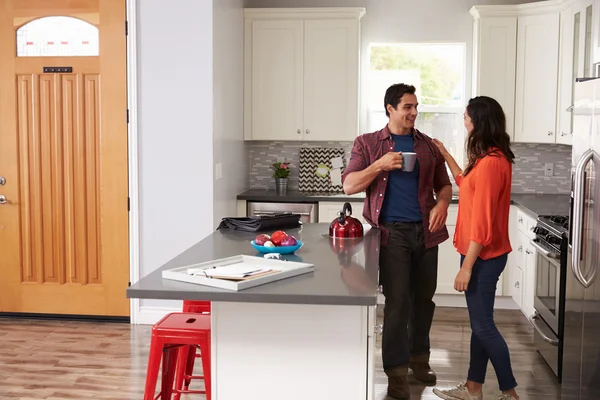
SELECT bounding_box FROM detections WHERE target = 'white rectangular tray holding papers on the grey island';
[162,255,315,291]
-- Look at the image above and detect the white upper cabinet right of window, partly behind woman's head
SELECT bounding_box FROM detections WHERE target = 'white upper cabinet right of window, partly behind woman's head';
[471,12,517,137]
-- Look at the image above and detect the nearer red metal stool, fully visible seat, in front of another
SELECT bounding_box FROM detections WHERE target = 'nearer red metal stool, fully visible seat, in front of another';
[144,313,211,400]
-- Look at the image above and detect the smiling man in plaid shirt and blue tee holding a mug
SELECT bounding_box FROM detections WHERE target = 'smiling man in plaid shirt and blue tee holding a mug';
[342,83,452,400]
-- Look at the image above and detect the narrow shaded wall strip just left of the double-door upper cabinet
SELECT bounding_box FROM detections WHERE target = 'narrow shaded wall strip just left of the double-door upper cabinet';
[213,0,248,228]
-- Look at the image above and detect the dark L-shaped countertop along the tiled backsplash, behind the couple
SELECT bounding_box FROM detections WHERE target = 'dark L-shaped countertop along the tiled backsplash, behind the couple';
[237,189,570,216]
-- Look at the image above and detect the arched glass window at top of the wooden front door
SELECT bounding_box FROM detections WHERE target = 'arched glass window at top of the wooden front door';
[17,17,99,57]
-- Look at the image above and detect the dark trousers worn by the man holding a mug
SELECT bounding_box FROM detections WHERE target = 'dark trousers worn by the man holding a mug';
[379,222,438,372]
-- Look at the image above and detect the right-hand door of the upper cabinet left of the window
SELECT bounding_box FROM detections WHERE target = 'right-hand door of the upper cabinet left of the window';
[304,20,359,141]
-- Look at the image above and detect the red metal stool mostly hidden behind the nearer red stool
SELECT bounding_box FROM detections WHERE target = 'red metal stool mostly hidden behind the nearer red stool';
[174,300,210,400]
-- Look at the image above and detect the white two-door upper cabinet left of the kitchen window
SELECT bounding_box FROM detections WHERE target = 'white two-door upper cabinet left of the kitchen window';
[244,8,365,141]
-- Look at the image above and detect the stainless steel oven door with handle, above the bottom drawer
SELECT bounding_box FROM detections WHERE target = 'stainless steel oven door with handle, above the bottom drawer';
[531,241,561,336]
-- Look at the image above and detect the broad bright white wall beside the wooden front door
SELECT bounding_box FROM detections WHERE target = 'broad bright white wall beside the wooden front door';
[137,0,216,307]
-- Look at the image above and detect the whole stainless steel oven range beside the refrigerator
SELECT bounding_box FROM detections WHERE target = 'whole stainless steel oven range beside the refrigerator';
[531,216,568,381]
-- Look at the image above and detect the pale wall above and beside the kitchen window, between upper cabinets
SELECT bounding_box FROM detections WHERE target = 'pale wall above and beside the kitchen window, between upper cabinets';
[246,0,532,132]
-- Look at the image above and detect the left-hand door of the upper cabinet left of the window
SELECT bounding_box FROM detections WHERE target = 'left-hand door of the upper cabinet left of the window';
[247,20,304,140]
